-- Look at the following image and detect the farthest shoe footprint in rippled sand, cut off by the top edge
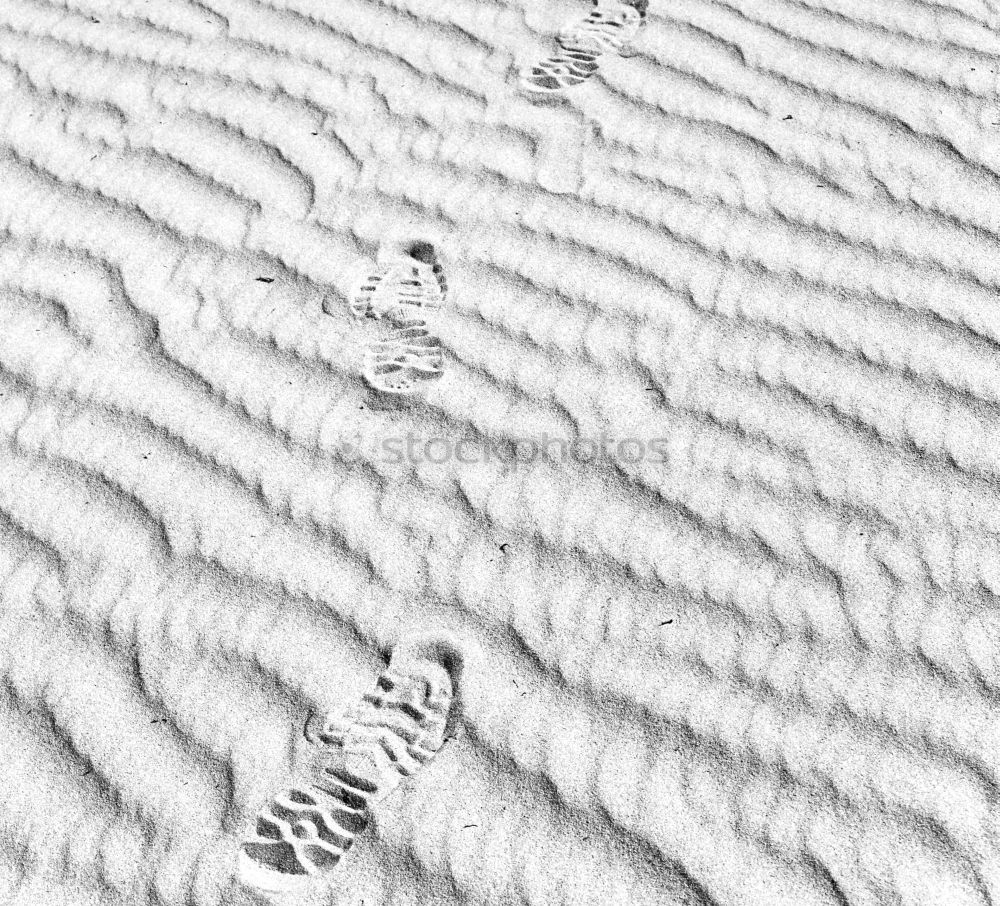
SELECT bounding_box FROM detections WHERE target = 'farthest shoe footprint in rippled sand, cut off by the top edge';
[521,0,648,94]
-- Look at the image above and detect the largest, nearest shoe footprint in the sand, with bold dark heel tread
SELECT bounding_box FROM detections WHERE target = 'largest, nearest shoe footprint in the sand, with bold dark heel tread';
[239,636,461,893]
